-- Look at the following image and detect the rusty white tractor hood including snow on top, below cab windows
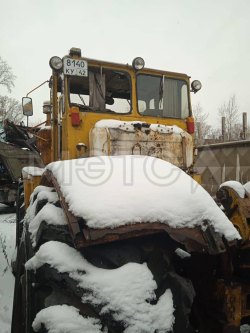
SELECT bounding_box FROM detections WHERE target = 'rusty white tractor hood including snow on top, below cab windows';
[89,119,193,170]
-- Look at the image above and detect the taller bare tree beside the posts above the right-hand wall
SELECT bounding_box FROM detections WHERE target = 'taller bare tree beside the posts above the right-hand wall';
[219,95,239,141]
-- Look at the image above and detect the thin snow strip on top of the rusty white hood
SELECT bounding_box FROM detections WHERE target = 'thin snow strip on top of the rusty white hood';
[95,119,184,134]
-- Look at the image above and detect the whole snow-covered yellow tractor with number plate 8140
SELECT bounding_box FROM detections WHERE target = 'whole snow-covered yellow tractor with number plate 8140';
[12,48,244,333]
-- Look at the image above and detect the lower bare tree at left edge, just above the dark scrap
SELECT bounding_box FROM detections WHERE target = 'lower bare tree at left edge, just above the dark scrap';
[0,96,23,124]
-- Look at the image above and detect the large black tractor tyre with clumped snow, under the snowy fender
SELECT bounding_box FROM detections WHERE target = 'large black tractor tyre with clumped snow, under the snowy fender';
[26,231,195,333]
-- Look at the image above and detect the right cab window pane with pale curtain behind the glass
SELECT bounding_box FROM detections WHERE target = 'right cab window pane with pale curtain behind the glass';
[137,74,189,119]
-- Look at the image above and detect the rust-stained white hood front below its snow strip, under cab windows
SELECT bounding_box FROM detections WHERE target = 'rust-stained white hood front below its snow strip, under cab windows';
[90,128,193,169]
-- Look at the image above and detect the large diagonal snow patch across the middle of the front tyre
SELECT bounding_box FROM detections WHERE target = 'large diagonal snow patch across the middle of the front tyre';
[25,241,174,333]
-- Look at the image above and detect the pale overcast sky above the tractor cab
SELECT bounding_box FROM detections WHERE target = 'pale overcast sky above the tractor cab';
[0,0,250,126]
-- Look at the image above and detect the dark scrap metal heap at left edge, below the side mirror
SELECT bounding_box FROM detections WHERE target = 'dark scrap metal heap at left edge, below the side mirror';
[0,120,43,206]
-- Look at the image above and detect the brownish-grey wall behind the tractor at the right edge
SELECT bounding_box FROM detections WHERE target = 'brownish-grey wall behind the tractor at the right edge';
[195,140,250,195]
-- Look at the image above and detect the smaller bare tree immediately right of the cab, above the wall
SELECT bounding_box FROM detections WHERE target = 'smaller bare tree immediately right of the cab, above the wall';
[193,103,211,145]
